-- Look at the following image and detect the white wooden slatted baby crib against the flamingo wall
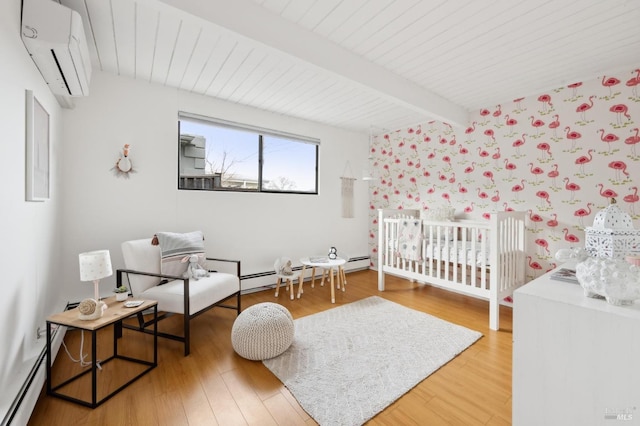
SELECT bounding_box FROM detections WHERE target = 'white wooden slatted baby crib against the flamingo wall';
[378,209,526,330]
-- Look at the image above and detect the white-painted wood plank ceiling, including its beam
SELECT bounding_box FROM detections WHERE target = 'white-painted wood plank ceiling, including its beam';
[60,0,640,132]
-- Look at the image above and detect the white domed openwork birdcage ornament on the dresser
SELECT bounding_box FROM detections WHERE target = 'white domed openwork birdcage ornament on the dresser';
[585,198,640,259]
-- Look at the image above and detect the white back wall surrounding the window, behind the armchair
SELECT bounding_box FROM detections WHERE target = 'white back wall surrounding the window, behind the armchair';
[60,72,368,301]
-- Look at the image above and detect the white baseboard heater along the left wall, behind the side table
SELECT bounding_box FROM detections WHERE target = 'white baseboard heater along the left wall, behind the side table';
[0,305,70,426]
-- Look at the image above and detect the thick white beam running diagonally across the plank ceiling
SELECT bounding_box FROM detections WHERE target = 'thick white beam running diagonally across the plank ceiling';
[161,0,469,127]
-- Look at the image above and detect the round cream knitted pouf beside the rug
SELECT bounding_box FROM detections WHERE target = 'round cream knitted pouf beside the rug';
[231,302,294,361]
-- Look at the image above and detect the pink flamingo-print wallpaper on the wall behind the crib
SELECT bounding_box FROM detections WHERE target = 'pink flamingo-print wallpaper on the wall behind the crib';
[369,65,640,280]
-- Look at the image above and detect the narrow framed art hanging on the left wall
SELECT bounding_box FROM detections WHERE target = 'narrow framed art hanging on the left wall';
[26,90,50,201]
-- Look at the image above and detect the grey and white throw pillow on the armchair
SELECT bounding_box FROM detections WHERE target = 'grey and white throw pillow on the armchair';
[156,231,206,277]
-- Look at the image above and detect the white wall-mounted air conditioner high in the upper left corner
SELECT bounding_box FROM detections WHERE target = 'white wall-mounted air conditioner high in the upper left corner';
[22,0,91,101]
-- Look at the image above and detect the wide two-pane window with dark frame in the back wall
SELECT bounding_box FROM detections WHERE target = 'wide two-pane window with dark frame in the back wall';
[178,113,320,194]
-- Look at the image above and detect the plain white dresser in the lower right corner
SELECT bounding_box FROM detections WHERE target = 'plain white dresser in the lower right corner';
[513,265,640,426]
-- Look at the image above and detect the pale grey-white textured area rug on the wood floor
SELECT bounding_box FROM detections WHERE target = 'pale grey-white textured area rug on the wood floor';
[263,296,482,426]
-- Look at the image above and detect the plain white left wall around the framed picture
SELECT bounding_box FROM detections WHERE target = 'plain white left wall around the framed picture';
[0,0,66,419]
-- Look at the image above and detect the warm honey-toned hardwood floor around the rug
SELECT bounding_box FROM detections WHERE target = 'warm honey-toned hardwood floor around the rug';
[29,271,512,426]
